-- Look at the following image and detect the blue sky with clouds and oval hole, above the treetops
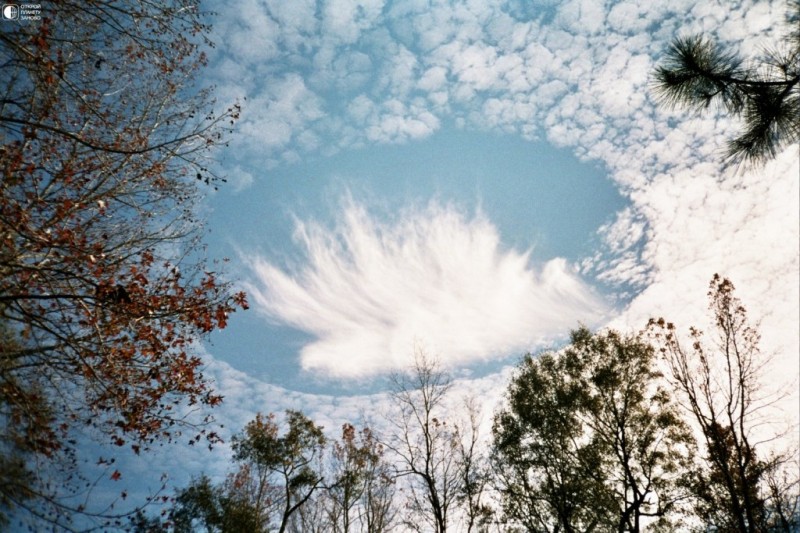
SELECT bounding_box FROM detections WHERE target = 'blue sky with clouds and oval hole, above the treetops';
[61,0,800,520]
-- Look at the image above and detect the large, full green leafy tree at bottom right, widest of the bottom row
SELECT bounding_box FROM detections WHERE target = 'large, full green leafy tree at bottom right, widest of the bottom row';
[493,328,691,532]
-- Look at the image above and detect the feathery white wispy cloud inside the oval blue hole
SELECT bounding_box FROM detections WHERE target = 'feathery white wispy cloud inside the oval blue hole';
[247,200,606,378]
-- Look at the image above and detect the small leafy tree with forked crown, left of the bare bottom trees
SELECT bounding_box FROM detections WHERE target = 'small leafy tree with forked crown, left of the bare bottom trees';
[233,410,325,533]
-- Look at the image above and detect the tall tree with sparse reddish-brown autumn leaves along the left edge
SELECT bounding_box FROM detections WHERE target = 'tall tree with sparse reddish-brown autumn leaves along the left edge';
[0,0,246,523]
